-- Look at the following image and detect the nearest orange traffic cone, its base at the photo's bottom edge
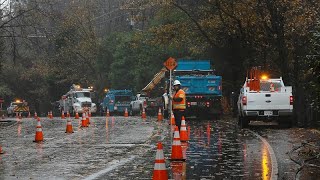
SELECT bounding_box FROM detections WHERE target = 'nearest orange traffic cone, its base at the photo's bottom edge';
[152,142,168,180]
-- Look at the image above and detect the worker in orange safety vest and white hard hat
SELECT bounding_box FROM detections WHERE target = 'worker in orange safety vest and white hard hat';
[171,80,186,131]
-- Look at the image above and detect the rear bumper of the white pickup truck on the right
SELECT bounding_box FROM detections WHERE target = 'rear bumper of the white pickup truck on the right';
[243,109,293,117]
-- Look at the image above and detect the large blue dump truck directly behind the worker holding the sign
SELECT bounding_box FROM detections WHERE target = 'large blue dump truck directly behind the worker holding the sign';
[173,60,222,117]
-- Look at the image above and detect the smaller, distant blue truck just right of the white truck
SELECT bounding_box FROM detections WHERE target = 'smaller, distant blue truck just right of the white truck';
[100,89,133,114]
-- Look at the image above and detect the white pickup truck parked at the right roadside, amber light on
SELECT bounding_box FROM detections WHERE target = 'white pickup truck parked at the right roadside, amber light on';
[237,78,293,128]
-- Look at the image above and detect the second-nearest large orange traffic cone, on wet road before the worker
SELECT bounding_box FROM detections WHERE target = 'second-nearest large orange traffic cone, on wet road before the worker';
[171,126,185,161]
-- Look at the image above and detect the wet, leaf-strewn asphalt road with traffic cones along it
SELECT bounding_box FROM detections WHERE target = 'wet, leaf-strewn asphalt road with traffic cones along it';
[0,114,320,179]
